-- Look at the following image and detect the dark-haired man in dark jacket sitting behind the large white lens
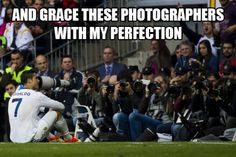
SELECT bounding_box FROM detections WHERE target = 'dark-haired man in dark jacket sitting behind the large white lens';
[54,55,83,130]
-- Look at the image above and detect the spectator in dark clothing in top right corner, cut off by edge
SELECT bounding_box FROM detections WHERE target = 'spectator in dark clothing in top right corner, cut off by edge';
[220,0,236,42]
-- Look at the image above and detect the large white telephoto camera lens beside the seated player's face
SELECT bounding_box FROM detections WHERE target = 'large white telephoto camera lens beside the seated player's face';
[37,76,71,90]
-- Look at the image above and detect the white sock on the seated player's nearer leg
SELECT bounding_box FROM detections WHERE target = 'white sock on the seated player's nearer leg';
[33,111,57,141]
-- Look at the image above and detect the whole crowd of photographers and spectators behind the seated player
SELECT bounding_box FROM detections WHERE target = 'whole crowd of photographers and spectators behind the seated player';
[0,0,236,141]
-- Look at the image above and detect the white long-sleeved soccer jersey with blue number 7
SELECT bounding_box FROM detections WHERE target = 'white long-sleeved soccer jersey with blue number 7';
[8,86,64,143]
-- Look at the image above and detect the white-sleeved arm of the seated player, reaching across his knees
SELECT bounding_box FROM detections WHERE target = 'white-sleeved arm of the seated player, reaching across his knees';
[38,92,65,113]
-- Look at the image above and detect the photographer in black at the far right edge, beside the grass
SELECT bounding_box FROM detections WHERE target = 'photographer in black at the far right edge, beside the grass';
[195,58,236,141]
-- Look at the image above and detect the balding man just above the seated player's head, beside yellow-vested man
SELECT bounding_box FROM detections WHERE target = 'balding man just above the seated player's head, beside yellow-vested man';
[35,55,55,78]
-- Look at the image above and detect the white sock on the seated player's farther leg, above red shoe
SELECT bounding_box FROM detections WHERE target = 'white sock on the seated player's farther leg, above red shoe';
[55,116,72,140]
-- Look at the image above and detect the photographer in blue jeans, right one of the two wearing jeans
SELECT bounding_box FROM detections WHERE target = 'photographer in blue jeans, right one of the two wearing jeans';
[129,75,172,141]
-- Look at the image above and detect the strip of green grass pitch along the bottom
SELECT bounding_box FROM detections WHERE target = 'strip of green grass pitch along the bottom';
[0,142,236,157]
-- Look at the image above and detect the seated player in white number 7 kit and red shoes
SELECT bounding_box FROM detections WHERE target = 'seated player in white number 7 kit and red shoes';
[8,71,77,143]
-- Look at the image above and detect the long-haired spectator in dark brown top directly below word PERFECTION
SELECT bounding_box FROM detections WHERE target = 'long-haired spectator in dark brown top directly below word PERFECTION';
[145,39,171,74]
